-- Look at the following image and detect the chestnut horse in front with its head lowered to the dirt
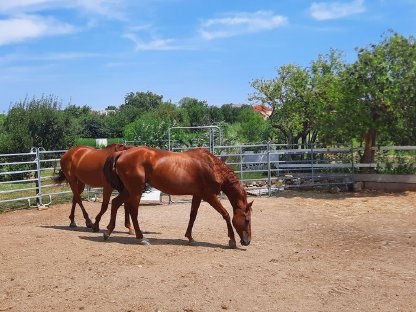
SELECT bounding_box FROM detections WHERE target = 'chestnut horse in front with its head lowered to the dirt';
[104,146,253,248]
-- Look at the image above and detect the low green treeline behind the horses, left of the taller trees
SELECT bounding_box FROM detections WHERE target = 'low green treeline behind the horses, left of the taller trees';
[0,92,268,154]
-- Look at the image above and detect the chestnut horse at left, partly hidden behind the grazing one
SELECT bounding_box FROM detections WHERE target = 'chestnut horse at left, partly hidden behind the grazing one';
[53,144,133,233]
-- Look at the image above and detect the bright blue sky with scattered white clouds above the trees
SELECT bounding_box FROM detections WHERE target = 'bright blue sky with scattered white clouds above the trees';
[0,0,416,113]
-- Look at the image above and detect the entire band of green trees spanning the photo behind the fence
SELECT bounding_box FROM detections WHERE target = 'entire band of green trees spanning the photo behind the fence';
[0,32,416,162]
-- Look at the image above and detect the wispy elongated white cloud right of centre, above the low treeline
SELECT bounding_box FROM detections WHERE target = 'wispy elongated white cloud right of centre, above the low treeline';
[199,11,288,40]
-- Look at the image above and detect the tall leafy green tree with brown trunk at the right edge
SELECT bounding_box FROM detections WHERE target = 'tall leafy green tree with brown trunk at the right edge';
[342,34,416,163]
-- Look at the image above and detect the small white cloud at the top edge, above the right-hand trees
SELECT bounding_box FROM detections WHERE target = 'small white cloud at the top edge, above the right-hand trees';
[309,0,365,21]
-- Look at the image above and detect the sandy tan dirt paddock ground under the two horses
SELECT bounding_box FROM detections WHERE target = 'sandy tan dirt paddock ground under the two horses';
[0,192,416,312]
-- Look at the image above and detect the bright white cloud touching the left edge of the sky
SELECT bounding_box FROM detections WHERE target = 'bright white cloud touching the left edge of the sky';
[0,15,76,46]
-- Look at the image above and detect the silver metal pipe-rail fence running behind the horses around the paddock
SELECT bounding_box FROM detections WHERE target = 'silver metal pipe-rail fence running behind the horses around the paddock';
[0,143,416,211]
